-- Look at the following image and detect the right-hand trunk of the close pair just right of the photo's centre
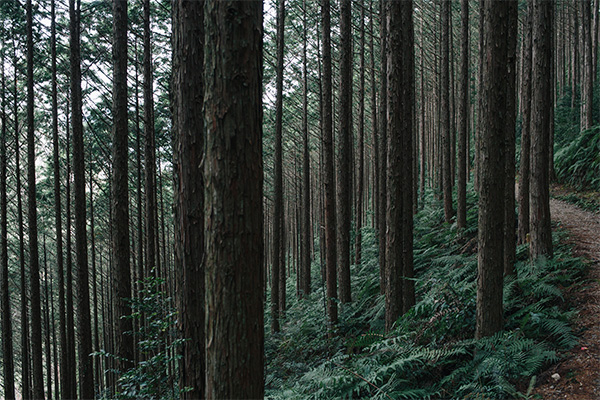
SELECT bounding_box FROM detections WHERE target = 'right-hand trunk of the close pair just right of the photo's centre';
[337,0,352,303]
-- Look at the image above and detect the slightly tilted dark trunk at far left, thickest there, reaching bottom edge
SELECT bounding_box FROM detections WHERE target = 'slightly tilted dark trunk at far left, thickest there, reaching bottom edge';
[69,0,94,399]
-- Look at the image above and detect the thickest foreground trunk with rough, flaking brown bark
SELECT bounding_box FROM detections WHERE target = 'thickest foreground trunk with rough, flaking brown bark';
[204,0,264,399]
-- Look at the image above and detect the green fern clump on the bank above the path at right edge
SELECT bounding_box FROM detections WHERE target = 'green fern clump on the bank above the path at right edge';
[554,126,600,190]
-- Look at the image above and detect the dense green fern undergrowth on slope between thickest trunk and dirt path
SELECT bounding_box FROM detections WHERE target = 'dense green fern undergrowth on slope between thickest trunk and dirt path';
[265,188,583,399]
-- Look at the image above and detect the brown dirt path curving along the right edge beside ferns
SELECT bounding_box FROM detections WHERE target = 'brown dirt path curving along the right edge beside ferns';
[533,187,600,400]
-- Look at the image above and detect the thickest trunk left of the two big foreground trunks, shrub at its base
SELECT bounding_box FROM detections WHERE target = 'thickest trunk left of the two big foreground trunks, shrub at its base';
[111,0,134,378]
